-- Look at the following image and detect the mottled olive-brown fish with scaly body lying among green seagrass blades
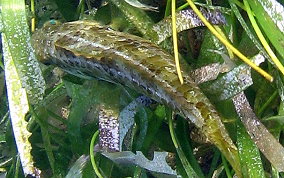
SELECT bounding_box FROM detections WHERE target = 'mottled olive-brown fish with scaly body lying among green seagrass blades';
[32,21,240,175]
